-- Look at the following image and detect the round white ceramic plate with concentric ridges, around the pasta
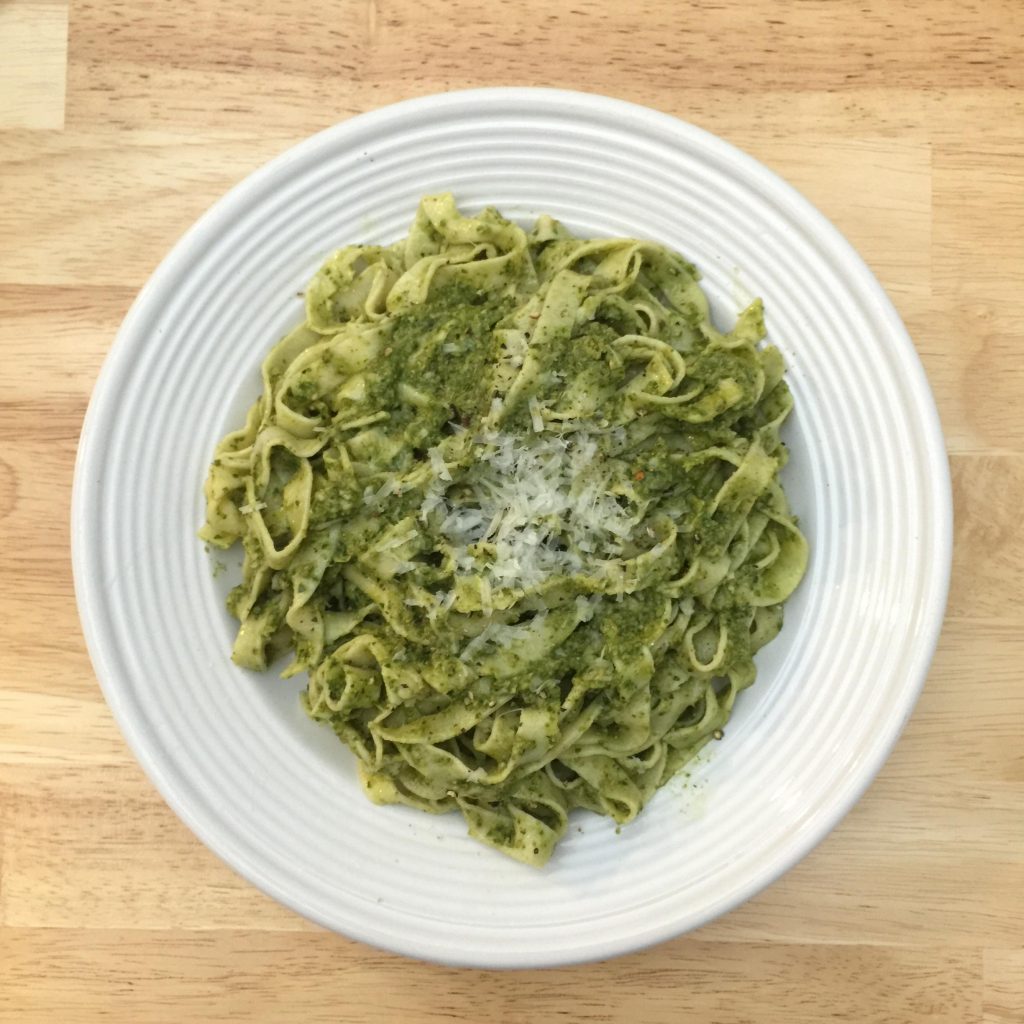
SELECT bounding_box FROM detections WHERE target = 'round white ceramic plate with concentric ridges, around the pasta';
[73,89,951,967]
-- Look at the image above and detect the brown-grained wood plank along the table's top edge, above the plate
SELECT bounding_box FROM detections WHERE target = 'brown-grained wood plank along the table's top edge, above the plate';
[61,0,1024,132]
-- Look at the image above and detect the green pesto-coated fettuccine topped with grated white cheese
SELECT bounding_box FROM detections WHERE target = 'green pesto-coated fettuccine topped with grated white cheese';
[201,195,807,864]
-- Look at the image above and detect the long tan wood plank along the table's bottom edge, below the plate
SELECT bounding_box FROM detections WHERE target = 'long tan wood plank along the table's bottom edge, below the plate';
[0,929,981,1024]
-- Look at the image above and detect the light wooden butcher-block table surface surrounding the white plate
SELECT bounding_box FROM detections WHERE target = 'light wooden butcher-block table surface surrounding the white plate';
[0,0,1024,1024]
